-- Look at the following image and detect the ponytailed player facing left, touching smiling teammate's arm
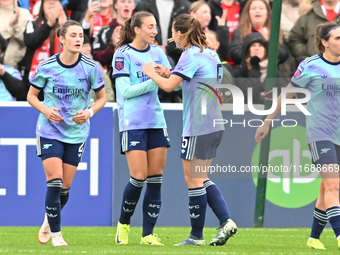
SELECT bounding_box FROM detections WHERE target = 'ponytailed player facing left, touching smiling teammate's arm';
[142,14,237,245]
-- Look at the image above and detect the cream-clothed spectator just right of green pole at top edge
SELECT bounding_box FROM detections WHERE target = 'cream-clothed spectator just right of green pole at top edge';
[281,0,301,42]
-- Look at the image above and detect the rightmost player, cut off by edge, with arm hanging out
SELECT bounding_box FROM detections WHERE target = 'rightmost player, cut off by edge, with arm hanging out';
[255,22,340,249]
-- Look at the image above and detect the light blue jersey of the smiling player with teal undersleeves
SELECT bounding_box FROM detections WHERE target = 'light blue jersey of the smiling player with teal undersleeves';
[112,44,171,132]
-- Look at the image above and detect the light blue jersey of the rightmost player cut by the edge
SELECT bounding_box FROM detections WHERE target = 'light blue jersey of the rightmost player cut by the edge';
[290,54,340,145]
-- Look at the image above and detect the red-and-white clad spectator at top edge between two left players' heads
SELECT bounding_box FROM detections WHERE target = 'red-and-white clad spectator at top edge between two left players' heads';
[82,0,115,42]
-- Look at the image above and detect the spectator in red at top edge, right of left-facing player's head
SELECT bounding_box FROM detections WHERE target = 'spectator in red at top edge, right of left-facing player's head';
[208,0,241,40]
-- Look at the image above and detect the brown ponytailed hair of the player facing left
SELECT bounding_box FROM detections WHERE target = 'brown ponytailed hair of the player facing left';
[168,14,213,51]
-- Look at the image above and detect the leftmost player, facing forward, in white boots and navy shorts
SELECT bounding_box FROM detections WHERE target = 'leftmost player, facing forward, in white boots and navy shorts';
[27,20,106,246]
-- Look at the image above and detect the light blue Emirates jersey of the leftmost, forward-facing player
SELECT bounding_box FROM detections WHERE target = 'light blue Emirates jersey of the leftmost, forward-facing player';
[30,53,104,144]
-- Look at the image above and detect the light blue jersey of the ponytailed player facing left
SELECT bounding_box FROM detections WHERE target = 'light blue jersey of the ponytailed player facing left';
[172,46,224,137]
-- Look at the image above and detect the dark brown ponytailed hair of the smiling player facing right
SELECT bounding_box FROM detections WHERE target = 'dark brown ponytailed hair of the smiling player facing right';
[117,11,153,48]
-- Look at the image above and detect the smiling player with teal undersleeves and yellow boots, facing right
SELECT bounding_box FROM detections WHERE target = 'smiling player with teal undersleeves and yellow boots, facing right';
[112,11,171,245]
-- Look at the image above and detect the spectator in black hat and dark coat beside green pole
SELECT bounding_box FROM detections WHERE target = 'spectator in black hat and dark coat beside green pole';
[234,32,288,104]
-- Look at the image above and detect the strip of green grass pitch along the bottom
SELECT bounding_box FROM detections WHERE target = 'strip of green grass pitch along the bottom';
[0,227,340,255]
